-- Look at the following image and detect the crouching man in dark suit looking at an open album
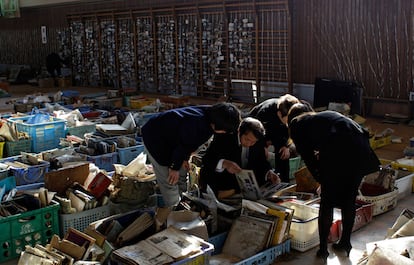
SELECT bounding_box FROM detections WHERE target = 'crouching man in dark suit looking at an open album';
[199,117,280,199]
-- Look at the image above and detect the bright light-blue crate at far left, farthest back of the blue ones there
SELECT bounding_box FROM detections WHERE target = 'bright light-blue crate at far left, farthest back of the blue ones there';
[8,115,66,153]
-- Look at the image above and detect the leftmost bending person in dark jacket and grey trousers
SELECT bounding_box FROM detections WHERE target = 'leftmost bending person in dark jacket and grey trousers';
[142,103,241,229]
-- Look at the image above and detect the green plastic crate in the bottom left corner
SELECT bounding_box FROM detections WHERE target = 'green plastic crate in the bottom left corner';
[0,201,59,263]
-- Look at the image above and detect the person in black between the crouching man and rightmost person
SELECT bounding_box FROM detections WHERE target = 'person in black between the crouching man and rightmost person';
[248,94,299,183]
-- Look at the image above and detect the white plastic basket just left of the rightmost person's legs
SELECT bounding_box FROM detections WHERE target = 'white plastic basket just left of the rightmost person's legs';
[283,202,319,252]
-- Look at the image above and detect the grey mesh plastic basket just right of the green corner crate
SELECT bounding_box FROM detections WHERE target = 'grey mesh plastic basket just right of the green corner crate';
[59,202,110,236]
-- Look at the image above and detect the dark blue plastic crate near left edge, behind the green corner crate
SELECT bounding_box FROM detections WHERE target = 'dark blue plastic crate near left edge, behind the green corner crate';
[0,156,50,186]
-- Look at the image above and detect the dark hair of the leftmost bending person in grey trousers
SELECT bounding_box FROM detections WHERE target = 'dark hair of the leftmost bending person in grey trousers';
[209,102,241,133]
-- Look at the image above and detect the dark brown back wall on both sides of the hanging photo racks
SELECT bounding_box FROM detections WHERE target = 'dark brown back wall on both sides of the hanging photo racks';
[0,0,413,115]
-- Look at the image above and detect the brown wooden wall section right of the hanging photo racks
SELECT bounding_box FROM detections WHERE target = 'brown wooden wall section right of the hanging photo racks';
[292,0,413,99]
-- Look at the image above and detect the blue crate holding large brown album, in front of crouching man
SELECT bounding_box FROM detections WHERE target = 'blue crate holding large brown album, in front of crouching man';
[208,233,290,265]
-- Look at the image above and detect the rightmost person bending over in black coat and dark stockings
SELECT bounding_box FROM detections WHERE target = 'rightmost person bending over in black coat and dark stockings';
[288,104,380,259]
